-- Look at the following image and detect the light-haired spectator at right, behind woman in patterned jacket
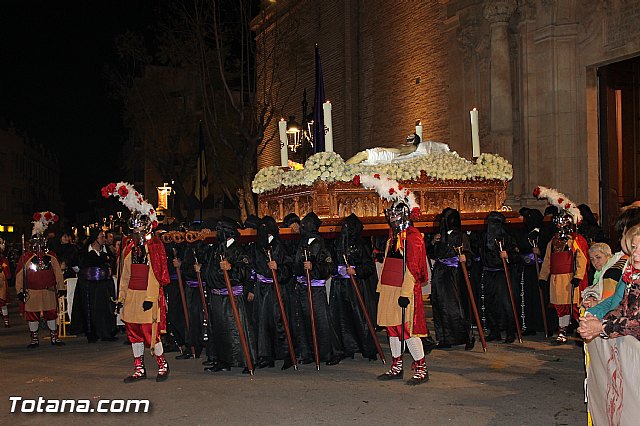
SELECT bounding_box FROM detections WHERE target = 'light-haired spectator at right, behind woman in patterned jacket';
[582,243,627,308]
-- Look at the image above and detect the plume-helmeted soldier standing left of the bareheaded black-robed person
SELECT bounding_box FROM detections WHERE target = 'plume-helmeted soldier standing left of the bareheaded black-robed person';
[16,211,64,348]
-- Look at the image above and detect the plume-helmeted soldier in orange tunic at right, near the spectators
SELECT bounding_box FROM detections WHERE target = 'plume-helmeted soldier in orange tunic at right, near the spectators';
[533,186,589,345]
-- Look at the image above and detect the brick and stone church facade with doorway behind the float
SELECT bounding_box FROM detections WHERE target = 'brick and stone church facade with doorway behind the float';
[254,0,640,236]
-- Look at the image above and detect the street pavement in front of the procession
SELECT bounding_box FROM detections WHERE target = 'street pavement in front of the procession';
[0,304,587,425]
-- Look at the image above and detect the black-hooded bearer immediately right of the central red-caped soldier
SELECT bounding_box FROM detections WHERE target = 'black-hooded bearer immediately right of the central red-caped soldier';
[427,207,475,350]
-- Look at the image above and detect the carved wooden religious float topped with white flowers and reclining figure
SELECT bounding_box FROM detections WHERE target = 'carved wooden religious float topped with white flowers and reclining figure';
[253,146,518,230]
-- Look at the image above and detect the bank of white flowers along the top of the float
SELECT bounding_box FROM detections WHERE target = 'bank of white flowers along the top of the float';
[252,151,513,194]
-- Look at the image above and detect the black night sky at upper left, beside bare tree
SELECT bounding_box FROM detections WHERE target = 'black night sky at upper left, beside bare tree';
[0,0,154,220]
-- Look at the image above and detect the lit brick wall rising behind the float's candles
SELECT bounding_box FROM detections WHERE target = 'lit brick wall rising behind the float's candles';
[258,0,449,167]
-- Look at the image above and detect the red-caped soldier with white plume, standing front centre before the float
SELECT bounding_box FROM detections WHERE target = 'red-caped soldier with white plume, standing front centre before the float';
[354,174,429,385]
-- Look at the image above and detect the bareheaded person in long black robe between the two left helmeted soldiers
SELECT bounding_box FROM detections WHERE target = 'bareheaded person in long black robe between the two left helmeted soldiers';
[71,228,117,343]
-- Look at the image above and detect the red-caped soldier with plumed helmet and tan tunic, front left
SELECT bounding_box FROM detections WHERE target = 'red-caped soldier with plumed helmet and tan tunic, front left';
[102,182,170,383]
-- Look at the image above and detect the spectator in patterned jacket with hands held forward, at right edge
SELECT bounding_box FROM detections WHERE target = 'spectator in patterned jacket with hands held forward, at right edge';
[578,225,640,339]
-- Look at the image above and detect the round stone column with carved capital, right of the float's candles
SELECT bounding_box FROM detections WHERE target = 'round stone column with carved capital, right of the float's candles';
[484,0,516,163]
